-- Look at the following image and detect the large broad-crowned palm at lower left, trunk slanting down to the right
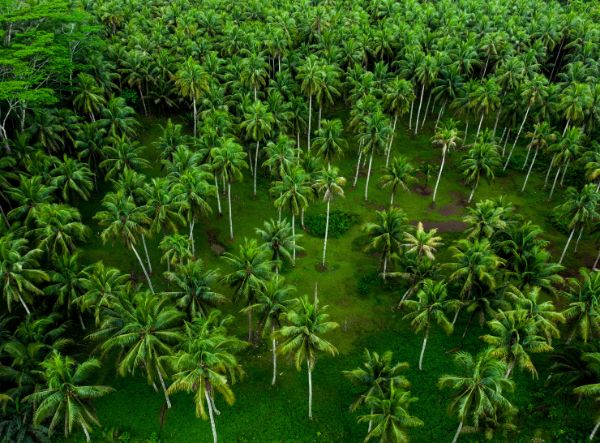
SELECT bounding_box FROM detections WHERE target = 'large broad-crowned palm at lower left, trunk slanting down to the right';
[90,291,184,408]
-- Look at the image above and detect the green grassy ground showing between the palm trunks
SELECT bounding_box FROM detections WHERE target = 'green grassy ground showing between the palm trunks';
[72,108,594,442]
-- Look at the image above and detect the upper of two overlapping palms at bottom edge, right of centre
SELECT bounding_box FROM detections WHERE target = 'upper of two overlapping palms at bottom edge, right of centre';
[342,349,410,432]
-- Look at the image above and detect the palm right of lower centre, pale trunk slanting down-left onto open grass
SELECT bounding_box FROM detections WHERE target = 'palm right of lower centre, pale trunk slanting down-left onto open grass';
[403,279,458,370]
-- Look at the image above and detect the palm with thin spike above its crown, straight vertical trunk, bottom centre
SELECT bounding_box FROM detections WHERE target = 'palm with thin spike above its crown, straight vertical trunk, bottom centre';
[277,287,339,420]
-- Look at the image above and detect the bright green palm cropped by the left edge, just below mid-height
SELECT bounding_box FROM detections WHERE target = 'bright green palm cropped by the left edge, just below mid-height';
[0,233,49,315]
